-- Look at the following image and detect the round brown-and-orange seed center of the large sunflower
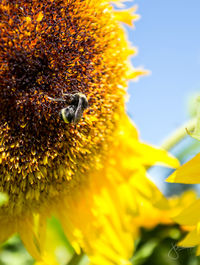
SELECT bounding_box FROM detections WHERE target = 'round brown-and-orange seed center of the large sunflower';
[0,0,128,211]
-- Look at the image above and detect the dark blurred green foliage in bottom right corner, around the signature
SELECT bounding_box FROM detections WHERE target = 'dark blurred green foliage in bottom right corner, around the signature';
[131,224,200,265]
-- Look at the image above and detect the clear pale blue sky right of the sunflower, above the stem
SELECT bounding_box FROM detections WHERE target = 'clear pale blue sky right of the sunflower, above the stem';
[127,0,200,145]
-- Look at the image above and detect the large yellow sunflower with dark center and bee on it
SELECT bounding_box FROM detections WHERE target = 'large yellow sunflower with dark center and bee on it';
[0,0,177,265]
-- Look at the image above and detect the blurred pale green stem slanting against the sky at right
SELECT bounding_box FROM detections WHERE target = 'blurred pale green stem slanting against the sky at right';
[161,118,197,151]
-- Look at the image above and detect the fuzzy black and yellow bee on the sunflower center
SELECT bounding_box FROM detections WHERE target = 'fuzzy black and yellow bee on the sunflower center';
[48,93,88,124]
